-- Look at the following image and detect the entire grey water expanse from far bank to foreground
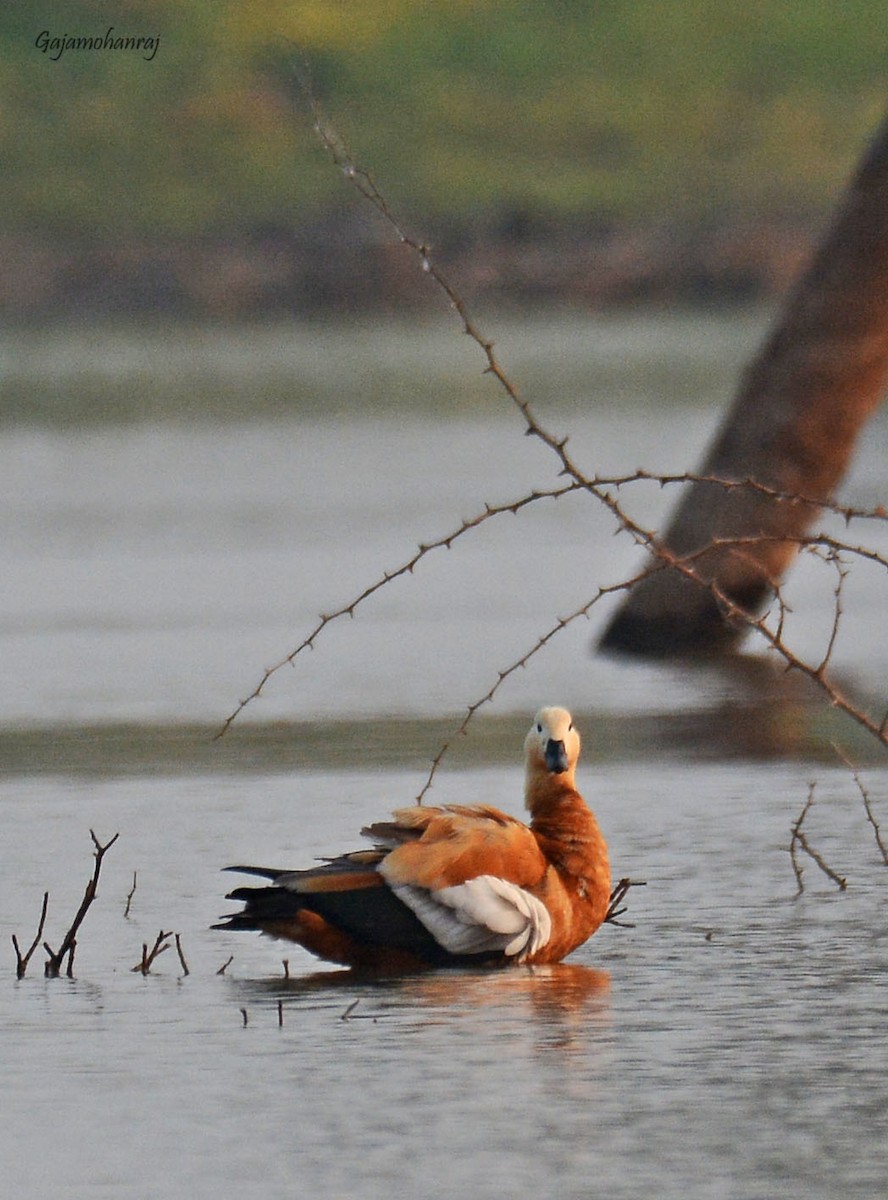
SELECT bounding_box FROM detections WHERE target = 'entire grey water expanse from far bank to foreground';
[0,312,888,1200]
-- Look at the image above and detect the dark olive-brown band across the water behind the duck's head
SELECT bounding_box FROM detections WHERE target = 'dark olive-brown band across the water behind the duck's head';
[0,696,882,784]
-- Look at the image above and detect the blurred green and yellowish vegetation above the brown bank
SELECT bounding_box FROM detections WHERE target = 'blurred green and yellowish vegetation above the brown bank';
[0,0,888,239]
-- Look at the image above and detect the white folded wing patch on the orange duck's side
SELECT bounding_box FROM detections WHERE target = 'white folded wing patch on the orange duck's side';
[391,875,552,960]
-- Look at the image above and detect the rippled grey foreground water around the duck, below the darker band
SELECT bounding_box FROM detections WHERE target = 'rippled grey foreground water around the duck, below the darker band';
[0,764,888,1200]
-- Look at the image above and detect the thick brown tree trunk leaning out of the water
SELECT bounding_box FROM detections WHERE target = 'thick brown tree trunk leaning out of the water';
[601,113,888,656]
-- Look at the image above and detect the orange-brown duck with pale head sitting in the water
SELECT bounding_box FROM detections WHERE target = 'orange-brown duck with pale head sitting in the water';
[214,707,611,971]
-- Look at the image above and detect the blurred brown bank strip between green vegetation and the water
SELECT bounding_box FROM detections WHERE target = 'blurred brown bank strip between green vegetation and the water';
[0,215,818,324]
